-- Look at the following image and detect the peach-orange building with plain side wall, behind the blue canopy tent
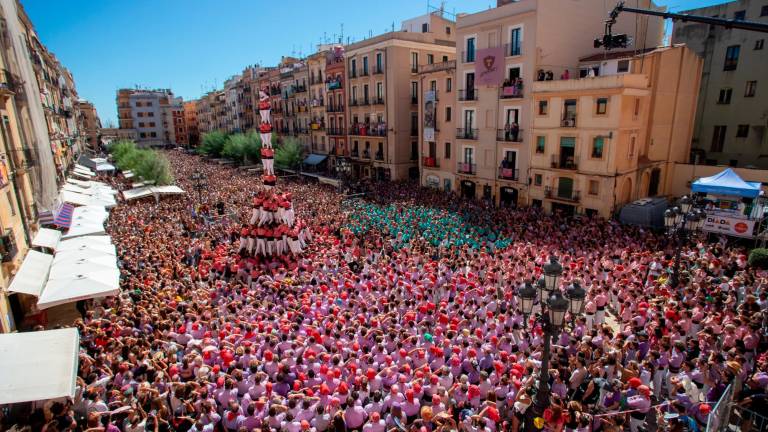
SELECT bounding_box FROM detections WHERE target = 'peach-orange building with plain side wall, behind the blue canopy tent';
[528,45,702,218]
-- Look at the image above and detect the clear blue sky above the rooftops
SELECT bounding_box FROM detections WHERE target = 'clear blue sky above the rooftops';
[21,0,721,125]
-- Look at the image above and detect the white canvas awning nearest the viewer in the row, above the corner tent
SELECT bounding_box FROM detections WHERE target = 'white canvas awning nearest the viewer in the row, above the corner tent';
[37,263,120,309]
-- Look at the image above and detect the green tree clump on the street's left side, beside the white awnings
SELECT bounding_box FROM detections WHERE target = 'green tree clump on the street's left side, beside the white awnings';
[109,140,173,185]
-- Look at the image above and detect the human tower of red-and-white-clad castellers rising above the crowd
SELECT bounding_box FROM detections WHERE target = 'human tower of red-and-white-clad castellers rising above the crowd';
[240,90,311,257]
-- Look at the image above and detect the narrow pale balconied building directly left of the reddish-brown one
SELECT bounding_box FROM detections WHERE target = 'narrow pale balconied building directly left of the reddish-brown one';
[307,50,328,154]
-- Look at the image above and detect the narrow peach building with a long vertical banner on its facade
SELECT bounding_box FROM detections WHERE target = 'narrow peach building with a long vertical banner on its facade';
[418,60,456,192]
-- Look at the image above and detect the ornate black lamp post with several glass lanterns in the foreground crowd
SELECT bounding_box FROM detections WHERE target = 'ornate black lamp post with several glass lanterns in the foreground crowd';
[518,257,586,431]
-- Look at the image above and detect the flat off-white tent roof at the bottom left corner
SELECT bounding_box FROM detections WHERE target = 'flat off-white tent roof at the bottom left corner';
[0,327,80,405]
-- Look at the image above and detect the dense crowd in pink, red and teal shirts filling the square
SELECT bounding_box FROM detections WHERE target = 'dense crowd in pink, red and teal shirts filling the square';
[7,152,768,432]
